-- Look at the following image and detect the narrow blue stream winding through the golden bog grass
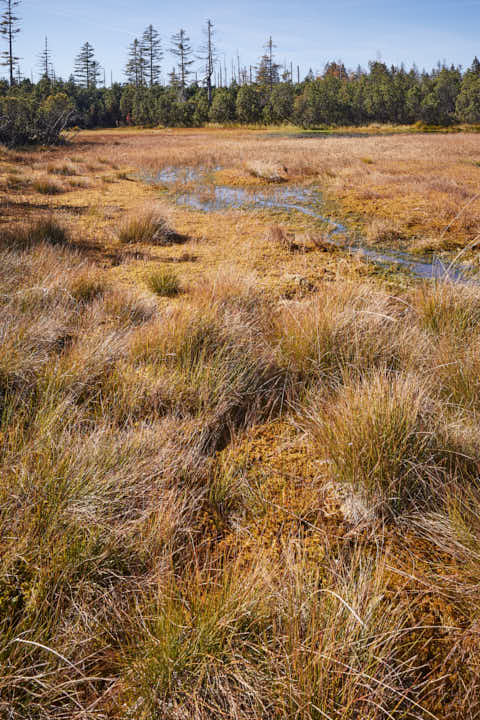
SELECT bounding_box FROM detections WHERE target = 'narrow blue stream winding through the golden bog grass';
[143,167,473,283]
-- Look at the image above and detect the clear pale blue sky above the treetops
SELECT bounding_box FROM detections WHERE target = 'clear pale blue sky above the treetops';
[10,0,480,80]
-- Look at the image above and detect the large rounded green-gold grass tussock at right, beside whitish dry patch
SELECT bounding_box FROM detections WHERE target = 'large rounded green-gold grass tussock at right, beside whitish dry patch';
[310,373,468,514]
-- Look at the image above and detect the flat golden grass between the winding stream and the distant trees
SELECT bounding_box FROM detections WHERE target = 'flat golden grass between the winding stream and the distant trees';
[66,129,480,250]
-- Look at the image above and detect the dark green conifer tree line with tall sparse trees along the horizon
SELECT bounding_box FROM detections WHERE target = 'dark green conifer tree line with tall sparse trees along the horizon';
[0,0,480,139]
